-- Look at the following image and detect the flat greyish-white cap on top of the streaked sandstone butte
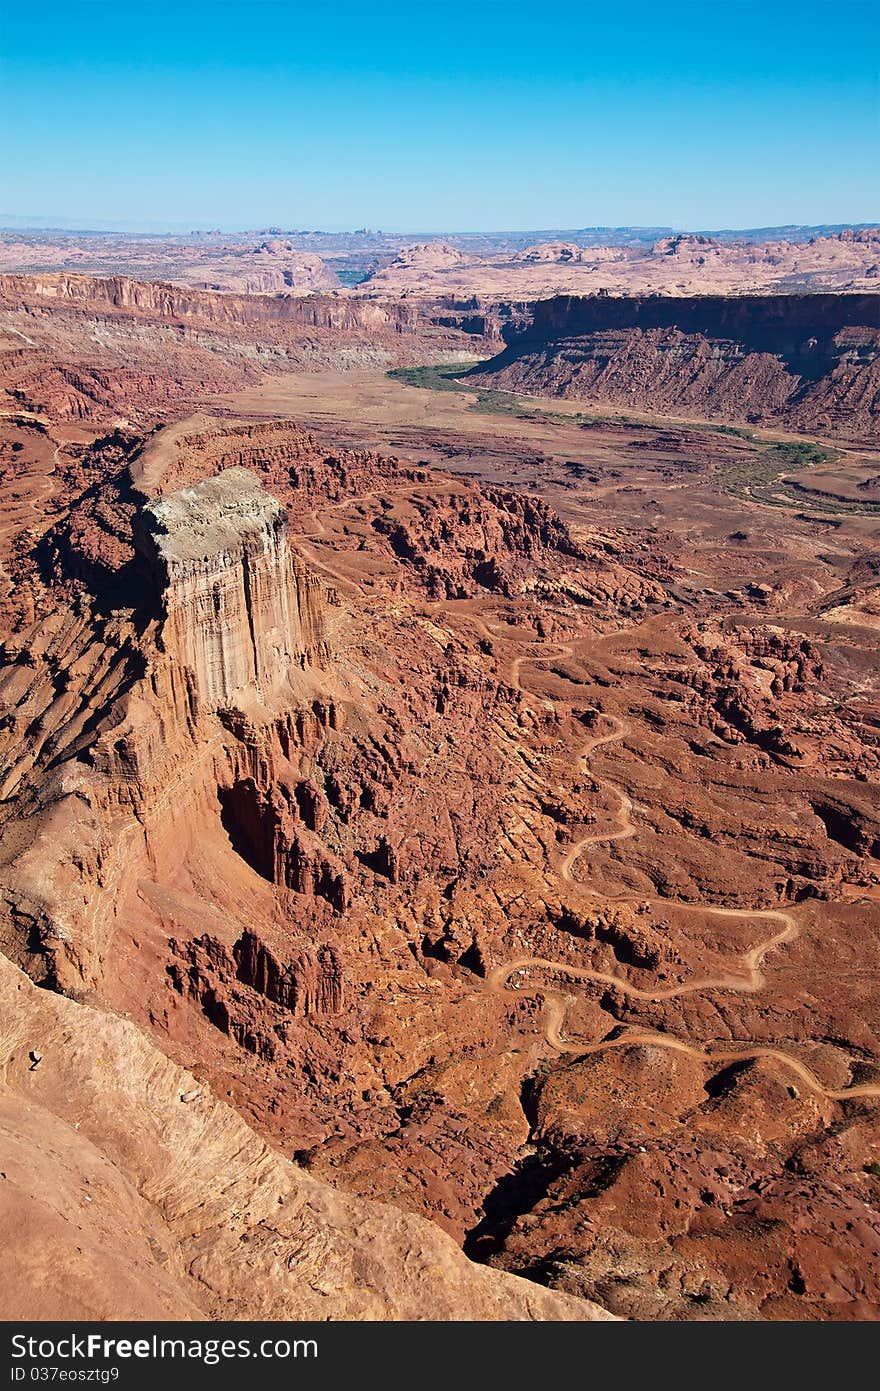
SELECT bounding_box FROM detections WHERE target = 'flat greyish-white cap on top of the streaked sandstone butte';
[143,467,284,563]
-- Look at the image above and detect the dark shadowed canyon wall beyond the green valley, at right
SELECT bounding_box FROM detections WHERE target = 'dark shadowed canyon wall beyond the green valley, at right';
[468,295,880,441]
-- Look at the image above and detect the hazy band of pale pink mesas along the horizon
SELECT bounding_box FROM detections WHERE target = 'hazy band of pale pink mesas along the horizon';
[0,225,880,303]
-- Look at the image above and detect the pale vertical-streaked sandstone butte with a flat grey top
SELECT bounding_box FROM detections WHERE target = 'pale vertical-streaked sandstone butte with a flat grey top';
[139,469,325,709]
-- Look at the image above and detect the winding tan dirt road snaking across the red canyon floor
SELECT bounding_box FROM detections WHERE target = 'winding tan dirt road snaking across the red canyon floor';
[478,623,880,1102]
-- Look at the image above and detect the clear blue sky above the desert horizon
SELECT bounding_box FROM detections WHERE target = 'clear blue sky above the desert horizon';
[0,0,880,232]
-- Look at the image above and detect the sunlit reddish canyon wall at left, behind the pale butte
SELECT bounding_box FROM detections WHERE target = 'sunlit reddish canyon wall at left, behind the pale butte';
[0,274,498,428]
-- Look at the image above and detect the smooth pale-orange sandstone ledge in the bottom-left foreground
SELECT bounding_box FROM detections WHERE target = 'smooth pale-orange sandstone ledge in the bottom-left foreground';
[0,957,610,1320]
